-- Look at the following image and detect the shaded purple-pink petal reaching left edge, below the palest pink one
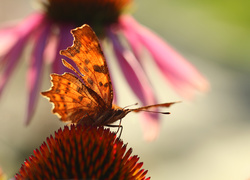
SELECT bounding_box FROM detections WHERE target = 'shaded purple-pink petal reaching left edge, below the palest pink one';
[0,14,44,95]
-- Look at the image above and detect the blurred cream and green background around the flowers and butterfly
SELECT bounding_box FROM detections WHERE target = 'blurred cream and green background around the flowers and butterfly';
[0,0,250,180]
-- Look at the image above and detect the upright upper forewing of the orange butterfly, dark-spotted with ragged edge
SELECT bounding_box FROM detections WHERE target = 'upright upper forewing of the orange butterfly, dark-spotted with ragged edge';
[60,25,113,108]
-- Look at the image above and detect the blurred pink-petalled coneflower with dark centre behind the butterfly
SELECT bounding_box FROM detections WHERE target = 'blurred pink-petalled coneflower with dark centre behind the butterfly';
[0,0,208,139]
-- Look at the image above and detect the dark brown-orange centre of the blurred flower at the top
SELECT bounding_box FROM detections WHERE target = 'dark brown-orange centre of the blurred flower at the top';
[44,0,131,35]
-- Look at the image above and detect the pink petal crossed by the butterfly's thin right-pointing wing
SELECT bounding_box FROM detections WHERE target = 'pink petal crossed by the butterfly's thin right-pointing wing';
[108,30,159,140]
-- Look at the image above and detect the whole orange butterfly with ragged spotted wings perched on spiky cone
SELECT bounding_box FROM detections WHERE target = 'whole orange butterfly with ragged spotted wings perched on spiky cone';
[41,25,177,127]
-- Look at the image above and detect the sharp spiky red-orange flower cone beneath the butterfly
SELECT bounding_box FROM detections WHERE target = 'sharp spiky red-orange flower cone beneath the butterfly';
[15,125,150,180]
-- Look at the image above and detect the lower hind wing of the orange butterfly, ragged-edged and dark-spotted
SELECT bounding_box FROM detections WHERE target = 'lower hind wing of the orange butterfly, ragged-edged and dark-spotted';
[41,73,98,123]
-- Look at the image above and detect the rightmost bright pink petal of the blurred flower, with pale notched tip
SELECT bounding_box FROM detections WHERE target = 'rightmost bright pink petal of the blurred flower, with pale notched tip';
[119,15,209,98]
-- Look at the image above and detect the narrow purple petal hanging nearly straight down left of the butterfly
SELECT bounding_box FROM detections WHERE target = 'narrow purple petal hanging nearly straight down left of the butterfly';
[25,22,51,125]
